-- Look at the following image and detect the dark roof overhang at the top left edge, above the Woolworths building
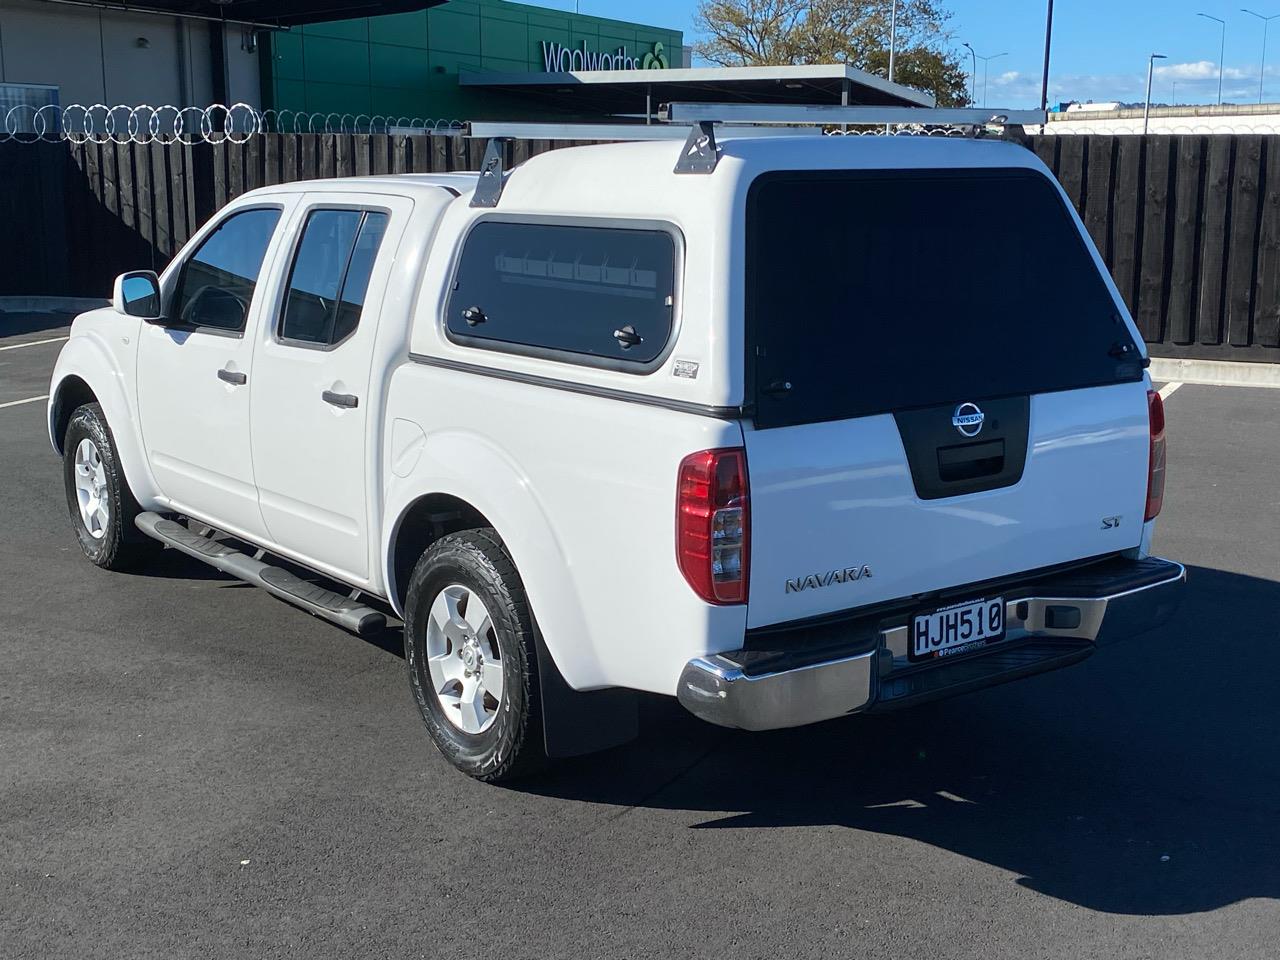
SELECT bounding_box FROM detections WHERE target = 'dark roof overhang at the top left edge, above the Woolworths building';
[54,0,445,27]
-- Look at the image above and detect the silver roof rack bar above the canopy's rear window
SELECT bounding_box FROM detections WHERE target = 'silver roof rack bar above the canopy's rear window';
[658,102,1047,125]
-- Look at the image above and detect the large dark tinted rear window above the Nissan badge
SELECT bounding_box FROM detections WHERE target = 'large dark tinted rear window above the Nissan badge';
[748,170,1142,426]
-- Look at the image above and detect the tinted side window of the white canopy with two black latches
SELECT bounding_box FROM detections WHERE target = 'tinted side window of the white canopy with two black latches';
[447,221,676,365]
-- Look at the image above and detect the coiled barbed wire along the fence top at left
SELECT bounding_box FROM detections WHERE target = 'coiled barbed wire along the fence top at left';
[0,104,465,145]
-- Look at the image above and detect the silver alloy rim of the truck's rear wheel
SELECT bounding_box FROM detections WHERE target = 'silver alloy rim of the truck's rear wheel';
[426,584,506,735]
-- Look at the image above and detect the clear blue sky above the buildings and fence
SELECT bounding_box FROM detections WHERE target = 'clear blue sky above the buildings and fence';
[525,0,1280,106]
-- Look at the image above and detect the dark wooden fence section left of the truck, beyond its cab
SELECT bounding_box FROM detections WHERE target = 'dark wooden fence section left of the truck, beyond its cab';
[0,133,573,305]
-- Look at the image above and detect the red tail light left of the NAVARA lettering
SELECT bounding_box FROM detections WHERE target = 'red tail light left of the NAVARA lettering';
[676,448,751,604]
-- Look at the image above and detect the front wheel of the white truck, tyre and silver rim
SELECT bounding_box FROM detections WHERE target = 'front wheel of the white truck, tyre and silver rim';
[63,403,152,570]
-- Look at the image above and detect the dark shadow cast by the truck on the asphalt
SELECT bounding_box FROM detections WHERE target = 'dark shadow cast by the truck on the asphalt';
[521,568,1280,915]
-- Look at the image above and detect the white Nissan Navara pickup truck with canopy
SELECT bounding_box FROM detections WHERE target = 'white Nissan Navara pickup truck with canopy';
[49,129,1185,781]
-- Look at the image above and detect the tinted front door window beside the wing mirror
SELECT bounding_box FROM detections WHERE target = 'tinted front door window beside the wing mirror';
[173,210,280,332]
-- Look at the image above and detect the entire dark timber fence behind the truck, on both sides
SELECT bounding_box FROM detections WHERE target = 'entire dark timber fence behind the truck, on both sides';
[0,133,1280,362]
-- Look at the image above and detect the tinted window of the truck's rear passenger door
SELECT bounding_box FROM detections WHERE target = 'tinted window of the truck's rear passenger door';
[280,210,387,344]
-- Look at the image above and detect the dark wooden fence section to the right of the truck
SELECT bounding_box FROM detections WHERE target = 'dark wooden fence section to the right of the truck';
[1032,134,1280,362]
